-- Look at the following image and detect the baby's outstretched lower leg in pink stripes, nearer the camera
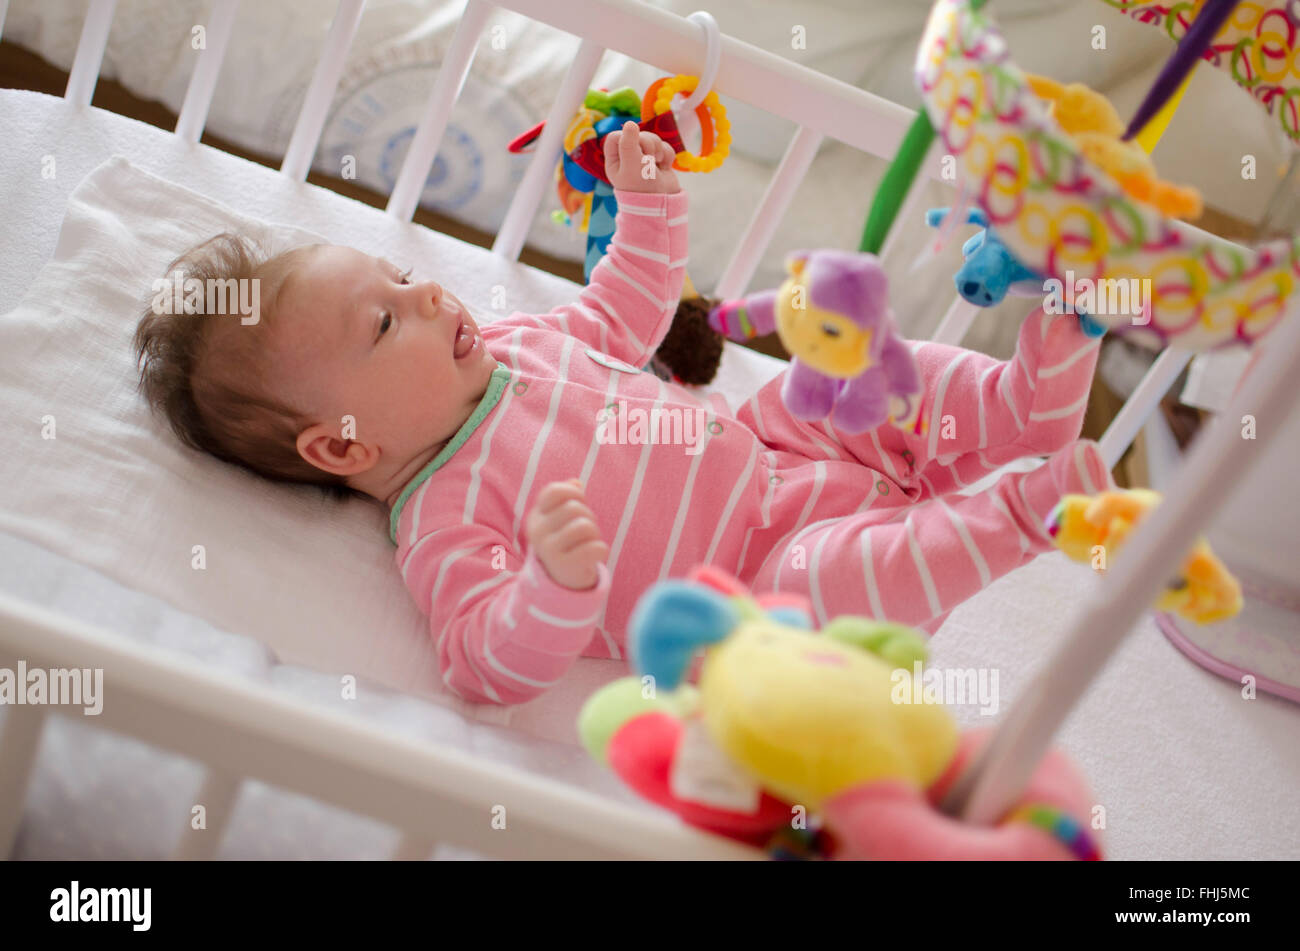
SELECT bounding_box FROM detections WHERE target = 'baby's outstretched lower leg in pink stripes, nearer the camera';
[750,440,1112,633]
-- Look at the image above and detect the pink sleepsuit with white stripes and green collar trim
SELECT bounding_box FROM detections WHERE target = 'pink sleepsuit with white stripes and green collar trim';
[391,191,1110,703]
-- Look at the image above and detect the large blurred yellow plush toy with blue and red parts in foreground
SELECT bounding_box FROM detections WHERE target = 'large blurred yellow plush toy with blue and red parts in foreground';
[579,568,1101,860]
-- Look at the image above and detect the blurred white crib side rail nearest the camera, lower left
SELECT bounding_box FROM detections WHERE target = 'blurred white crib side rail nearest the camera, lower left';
[0,594,762,859]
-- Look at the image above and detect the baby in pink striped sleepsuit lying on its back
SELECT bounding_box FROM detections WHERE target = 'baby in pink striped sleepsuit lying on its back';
[135,122,1110,703]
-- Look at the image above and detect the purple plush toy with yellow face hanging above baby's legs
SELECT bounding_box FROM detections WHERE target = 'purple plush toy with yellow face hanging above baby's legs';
[709,251,922,433]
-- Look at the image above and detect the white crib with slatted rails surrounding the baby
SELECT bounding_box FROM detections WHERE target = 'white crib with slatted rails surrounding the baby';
[0,0,1300,859]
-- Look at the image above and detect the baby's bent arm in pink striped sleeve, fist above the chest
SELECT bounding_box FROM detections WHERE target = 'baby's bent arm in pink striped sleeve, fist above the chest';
[403,482,610,704]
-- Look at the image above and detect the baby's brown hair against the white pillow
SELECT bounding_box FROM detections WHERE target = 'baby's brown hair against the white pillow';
[134,231,352,496]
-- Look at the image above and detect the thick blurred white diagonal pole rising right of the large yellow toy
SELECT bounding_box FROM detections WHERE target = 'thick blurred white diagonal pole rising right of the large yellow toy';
[944,297,1300,825]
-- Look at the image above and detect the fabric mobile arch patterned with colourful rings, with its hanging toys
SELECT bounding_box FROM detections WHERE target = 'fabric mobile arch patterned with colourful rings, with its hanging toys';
[904,0,1300,351]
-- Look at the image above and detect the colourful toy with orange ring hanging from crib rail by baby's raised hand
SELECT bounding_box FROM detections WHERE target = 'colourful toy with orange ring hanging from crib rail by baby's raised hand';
[508,13,732,385]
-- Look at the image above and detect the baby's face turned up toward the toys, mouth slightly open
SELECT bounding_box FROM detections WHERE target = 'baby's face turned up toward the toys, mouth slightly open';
[274,246,497,468]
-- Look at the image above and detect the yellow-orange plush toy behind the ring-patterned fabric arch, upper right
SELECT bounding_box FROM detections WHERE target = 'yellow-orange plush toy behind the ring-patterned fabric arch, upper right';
[1026,74,1203,220]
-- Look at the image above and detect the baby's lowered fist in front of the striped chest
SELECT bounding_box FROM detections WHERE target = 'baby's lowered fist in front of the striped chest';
[525,479,610,591]
